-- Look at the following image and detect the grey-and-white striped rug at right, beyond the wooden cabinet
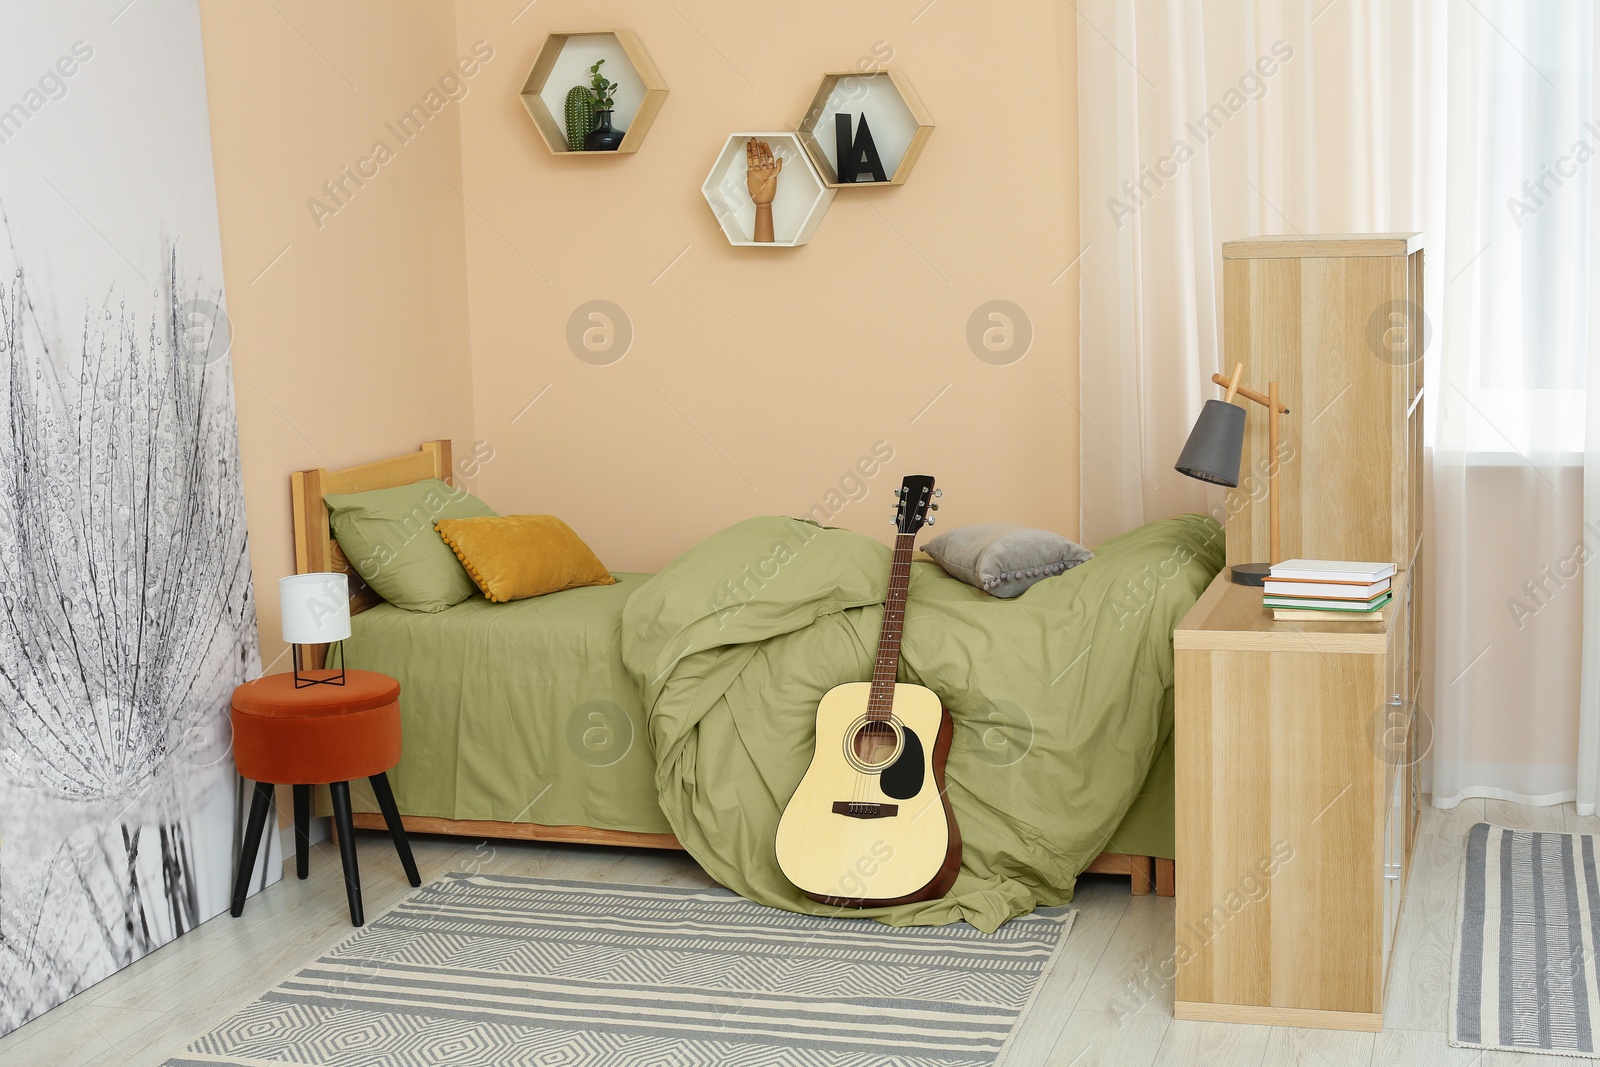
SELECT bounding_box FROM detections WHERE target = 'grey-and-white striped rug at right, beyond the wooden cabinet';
[1450,822,1600,1059]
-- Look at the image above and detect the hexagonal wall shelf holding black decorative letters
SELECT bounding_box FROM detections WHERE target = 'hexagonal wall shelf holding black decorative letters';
[798,70,933,189]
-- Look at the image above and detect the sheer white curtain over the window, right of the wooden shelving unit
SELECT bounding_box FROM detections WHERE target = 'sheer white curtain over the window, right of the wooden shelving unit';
[1424,0,1600,811]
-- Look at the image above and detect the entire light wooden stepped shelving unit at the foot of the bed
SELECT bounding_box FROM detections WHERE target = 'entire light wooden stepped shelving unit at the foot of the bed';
[1173,234,1422,1030]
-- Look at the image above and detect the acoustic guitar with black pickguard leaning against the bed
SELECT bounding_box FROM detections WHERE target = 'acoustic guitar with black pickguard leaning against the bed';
[778,475,962,907]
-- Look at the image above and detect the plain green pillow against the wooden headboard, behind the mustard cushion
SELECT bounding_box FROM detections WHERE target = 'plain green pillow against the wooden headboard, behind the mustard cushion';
[322,478,494,611]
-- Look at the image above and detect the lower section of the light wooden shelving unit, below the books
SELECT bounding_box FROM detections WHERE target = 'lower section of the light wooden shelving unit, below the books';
[1173,571,1421,1030]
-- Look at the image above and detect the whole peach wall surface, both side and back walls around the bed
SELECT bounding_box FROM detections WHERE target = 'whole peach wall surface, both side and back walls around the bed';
[202,0,1078,669]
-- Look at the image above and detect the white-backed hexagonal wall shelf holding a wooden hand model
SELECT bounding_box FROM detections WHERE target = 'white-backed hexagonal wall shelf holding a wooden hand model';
[701,131,834,248]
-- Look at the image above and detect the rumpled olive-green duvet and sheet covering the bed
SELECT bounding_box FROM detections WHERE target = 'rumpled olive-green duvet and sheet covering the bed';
[346,517,1222,929]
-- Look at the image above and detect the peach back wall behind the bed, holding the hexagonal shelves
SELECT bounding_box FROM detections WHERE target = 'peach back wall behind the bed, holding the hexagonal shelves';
[456,0,1078,569]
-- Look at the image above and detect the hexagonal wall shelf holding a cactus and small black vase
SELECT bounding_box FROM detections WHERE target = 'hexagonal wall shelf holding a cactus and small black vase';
[522,30,667,155]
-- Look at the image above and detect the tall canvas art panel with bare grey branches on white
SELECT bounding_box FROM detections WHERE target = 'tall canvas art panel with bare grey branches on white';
[0,0,278,1032]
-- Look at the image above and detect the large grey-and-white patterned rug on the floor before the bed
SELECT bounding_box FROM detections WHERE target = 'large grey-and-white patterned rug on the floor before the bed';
[166,873,1074,1067]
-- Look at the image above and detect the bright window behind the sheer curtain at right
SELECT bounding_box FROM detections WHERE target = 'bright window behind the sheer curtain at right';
[1435,0,1600,456]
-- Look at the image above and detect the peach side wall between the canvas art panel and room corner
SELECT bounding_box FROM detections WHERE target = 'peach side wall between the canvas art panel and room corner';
[202,0,478,672]
